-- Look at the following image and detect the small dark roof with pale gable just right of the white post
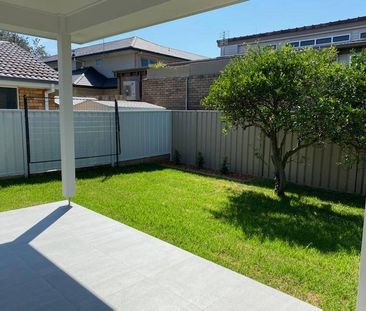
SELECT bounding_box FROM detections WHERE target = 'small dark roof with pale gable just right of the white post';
[72,67,117,89]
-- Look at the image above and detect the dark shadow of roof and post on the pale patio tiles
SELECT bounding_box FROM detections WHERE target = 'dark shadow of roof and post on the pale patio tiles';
[0,206,112,311]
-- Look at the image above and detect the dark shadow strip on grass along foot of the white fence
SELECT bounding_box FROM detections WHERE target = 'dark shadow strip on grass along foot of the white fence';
[0,164,165,188]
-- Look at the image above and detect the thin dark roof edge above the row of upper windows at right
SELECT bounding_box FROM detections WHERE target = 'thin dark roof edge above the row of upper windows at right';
[217,16,366,45]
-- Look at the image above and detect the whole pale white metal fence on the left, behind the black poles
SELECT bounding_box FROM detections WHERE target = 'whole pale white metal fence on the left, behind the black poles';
[0,110,171,177]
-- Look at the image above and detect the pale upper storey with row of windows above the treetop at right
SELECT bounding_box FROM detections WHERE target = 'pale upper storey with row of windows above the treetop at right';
[217,16,366,63]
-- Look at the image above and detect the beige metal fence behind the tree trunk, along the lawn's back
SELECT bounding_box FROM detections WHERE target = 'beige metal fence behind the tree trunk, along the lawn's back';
[172,111,366,194]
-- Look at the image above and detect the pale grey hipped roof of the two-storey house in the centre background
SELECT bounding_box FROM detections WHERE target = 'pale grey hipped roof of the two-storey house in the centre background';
[43,37,207,63]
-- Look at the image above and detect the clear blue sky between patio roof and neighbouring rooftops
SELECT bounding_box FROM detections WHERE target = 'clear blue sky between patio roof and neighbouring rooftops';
[32,0,366,57]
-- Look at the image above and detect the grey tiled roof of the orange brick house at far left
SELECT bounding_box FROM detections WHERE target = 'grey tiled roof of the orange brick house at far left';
[0,41,58,82]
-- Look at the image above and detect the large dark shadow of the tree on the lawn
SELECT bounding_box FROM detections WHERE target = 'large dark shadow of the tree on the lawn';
[212,191,363,253]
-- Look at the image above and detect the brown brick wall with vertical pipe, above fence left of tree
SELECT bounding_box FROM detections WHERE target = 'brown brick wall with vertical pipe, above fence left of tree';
[142,75,217,110]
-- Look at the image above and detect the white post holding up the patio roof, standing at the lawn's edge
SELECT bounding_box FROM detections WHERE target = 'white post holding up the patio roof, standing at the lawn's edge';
[57,17,75,200]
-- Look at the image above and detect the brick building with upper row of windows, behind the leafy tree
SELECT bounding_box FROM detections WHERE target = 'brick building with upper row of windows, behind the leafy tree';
[142,17,366,110]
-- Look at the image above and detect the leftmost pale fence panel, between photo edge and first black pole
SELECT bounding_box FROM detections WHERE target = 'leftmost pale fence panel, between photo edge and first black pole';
[0,110,24,177]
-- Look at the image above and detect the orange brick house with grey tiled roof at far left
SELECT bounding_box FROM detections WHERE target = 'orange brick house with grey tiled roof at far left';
[0,41,58,109]
